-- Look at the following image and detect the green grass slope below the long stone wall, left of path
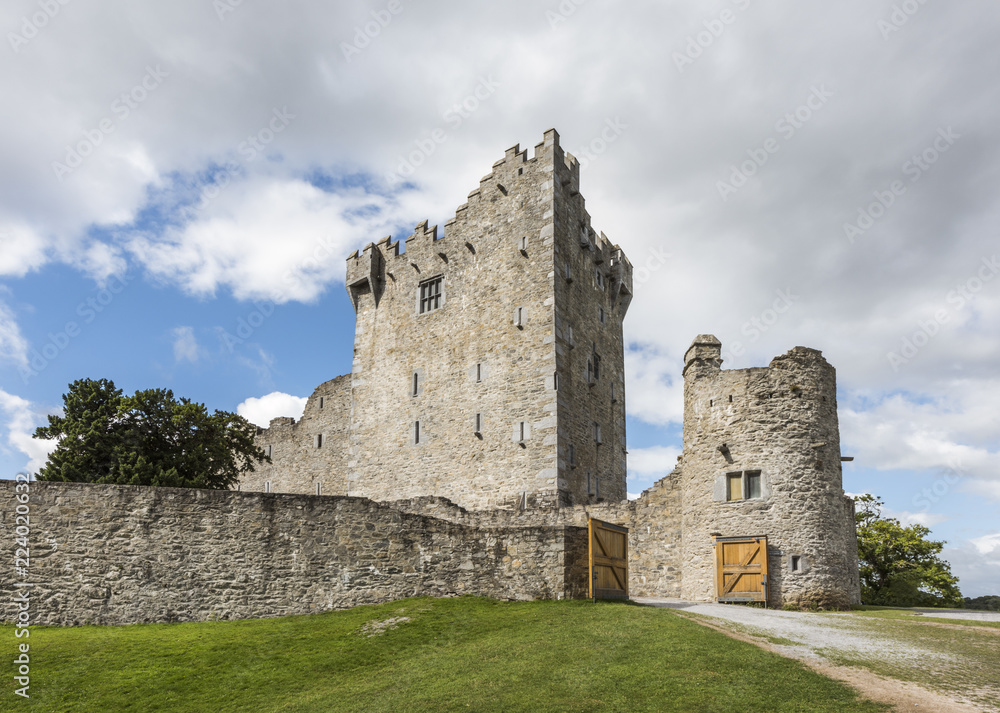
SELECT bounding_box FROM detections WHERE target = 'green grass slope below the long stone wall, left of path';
[0,597,887,713]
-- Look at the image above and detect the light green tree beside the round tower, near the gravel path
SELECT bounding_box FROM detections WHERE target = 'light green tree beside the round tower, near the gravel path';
[854,493,964,607]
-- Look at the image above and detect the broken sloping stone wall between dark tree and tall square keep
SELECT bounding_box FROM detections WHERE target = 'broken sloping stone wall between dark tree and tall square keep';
[239,374,351,495]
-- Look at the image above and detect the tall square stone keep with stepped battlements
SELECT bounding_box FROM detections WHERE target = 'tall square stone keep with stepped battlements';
[346,130,632,509]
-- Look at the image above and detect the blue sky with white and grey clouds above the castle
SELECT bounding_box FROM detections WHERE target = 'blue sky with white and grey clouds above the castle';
[0,0,1000,595]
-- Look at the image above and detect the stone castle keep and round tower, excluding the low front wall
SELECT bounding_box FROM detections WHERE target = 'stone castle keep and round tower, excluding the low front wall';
[241,130,859,603]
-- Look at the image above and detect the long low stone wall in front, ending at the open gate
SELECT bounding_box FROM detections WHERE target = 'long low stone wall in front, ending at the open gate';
[0,481,586,624]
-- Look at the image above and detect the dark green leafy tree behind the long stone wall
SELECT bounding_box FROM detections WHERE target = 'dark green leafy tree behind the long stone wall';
[34,379,270,489]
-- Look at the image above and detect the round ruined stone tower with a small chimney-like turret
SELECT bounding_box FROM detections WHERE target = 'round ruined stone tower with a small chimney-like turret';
[680,335,860,606]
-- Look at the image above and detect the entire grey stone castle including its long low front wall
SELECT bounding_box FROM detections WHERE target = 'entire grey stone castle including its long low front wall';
[0,130,860,624]
